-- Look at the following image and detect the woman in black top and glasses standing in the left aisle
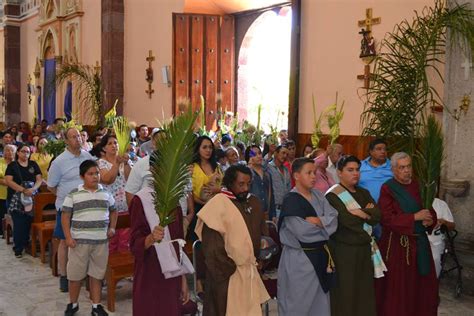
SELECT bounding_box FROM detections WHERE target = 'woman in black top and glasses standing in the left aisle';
[5,144,43,258]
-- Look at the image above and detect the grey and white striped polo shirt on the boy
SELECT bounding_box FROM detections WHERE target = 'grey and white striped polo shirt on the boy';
[61,184,115,244]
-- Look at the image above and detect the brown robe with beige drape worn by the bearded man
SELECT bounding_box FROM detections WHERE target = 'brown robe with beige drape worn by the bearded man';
[196,193,269,316]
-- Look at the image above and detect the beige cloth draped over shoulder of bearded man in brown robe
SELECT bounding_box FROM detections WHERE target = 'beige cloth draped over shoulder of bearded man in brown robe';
[195,194,270,316]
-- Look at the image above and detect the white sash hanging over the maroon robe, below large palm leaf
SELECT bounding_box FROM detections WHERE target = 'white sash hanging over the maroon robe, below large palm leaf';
[136,186,194,279]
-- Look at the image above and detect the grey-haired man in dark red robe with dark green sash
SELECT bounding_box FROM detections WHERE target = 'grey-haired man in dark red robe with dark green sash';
[375,152,439,316]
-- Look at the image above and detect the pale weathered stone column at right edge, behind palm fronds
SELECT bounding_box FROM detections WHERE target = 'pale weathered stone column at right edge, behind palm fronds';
[441,0,474,293]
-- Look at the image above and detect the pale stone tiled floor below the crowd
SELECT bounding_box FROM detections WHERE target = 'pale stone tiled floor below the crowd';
[0,240,474,316]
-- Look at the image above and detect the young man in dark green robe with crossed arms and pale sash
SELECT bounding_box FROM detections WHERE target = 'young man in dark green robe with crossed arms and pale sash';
[326,156,386,316]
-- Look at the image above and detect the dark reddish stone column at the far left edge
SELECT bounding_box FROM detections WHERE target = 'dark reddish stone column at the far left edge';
[3,2,21,125]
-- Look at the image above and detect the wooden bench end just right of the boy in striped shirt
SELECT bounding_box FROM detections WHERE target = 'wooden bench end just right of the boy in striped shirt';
[105,214,135,312]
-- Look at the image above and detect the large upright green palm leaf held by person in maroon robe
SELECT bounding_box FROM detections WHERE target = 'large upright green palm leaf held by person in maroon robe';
[150,106,199,227]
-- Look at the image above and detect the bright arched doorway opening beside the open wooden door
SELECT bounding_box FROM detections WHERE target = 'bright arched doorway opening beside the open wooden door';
[237,6,292,132]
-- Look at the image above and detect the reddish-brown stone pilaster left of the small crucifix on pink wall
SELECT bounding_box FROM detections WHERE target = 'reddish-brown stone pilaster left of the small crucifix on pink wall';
[101,0,124,114]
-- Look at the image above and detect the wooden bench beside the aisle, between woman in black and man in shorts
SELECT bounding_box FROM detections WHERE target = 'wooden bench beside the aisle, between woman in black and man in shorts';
[31,192,56,263]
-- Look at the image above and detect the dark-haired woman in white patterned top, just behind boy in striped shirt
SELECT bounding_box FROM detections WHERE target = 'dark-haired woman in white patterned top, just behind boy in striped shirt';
[97,134,131,253]
